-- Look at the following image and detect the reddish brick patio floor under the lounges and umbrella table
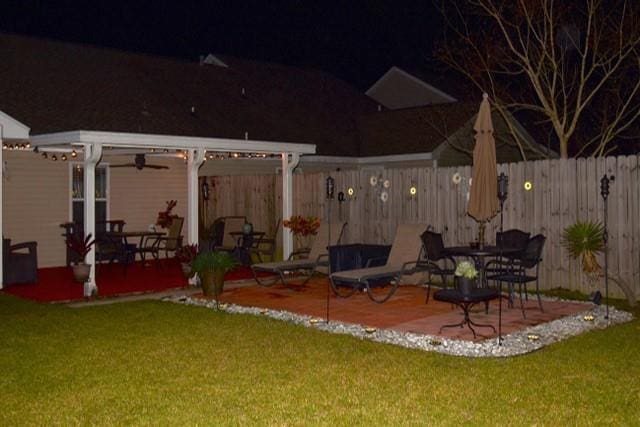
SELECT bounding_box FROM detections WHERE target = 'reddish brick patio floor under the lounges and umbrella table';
[212,279,592,340]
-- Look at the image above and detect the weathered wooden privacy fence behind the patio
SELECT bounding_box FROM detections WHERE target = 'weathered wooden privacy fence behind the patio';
[209,156,640,296]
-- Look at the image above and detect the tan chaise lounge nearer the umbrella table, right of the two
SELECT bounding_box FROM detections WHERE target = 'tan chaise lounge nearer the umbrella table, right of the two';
[329,224,427,303]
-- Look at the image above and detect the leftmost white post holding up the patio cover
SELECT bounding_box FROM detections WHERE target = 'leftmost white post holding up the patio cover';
[84,144,102,296]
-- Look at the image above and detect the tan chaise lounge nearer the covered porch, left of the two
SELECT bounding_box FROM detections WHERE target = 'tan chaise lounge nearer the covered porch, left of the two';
[251,222,347,286]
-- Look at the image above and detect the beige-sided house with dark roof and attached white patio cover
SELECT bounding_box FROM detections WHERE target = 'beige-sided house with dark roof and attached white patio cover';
[0,34,552,294]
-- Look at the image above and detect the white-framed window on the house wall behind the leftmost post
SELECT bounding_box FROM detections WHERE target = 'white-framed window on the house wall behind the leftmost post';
[71,164,109,231]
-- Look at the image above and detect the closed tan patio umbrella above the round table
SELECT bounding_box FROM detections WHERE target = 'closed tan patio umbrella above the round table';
[467,93,498,244]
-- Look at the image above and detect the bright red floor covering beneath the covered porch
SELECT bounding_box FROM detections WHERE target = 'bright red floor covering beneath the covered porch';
[3,259,262,302]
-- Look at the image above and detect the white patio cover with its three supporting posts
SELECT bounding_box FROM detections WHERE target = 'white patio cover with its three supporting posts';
[21,130,316,295]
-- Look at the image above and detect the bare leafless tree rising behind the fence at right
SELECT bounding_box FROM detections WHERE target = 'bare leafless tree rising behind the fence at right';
[438,0,640,158]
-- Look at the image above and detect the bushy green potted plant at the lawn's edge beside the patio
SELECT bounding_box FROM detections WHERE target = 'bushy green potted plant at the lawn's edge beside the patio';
[191,251,238,299]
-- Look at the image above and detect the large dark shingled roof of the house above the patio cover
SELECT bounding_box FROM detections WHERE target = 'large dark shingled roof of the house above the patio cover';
[0,34,376,156]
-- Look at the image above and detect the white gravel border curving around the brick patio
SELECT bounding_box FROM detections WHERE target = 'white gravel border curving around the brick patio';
[163,296,633,357]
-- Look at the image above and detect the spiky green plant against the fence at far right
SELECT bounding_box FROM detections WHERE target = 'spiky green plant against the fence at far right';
[560,221,604,274]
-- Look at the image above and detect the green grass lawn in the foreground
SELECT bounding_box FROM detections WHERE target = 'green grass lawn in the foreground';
[0,294,640,426]
